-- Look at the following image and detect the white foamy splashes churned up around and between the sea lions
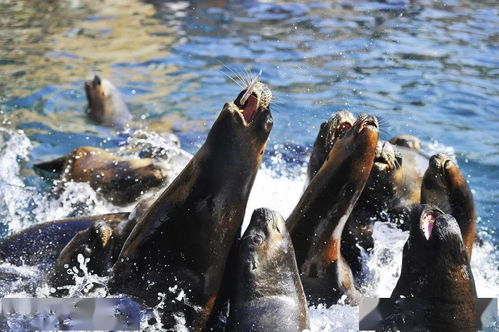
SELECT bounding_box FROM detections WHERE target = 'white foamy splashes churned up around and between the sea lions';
[0,128,499,331]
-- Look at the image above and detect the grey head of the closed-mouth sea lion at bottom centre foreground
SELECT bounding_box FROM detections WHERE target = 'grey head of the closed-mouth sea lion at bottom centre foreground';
[239,208,296,284]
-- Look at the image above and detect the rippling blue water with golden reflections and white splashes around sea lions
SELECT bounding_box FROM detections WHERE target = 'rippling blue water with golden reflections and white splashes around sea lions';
[0,0,499,331]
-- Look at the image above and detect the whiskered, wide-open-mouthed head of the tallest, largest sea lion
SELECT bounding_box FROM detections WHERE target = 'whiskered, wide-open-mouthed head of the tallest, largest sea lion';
[207,77,273,169]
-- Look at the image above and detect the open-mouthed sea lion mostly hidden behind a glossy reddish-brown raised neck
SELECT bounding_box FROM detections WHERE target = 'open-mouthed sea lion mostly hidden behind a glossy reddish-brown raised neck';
[305,110,355,186]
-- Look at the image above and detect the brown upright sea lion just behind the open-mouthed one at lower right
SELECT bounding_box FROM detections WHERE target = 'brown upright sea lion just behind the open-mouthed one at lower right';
[421,153,476,258]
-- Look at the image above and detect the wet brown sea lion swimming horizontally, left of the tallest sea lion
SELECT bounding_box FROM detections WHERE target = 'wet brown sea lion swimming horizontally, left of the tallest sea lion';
[35,146,169,206]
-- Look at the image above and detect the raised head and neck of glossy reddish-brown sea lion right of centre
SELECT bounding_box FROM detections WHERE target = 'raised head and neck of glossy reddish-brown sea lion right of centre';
[287,116,379,268]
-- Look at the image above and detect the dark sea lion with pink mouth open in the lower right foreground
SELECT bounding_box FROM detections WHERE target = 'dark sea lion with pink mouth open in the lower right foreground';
[384,205,477,331]
